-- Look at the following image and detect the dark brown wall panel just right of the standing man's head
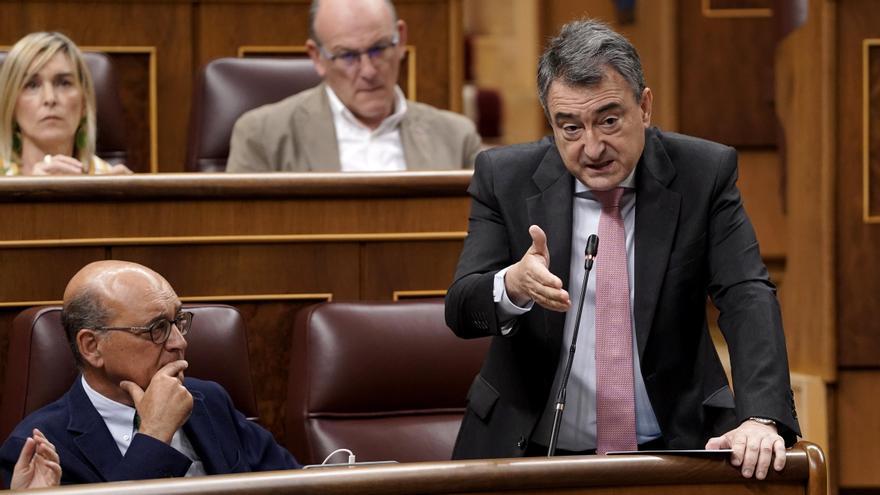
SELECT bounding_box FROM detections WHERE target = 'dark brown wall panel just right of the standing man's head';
[678,0,776,148]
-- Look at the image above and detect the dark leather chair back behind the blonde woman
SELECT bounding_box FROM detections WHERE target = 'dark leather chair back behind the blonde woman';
[0,52,130,166]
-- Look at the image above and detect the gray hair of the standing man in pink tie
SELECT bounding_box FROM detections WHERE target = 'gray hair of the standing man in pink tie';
[538,19,645,114]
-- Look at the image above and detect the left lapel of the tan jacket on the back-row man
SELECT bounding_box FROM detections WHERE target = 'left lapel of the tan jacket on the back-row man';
[302,83,342,172]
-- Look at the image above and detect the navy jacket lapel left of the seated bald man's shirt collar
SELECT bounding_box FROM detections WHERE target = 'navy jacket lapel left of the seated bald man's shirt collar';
[67,376,122,480]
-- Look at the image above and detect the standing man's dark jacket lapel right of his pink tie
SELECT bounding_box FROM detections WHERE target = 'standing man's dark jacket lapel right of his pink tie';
[634,129,681,356]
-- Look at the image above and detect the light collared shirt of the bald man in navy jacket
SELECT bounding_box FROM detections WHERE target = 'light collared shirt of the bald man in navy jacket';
[80,376,207,476]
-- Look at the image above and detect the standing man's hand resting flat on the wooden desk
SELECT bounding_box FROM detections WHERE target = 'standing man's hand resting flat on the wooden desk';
[706,419,785,480]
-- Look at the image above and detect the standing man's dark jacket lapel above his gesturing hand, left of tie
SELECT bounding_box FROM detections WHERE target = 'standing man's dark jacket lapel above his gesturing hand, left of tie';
[526,141,574,349]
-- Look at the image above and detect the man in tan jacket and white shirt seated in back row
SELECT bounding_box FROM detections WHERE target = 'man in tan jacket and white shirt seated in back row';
[226,0,480,172]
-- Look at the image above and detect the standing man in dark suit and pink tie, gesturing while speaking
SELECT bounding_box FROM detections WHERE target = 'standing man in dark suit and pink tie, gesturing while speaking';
[446,21,799,478]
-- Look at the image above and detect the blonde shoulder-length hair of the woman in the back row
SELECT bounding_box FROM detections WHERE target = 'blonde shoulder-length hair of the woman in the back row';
[0,32,96,164]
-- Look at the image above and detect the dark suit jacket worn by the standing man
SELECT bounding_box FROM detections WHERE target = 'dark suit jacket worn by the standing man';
[446,129,798,458]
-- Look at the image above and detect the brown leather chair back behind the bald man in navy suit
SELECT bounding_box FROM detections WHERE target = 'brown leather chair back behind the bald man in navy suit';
[0,305,257,440]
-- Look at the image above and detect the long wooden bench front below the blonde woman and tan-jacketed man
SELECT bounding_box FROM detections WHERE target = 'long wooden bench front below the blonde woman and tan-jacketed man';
[0,171,471,439]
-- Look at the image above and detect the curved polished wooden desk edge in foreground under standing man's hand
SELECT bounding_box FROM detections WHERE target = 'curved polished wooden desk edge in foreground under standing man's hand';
[0,442,826,495]
